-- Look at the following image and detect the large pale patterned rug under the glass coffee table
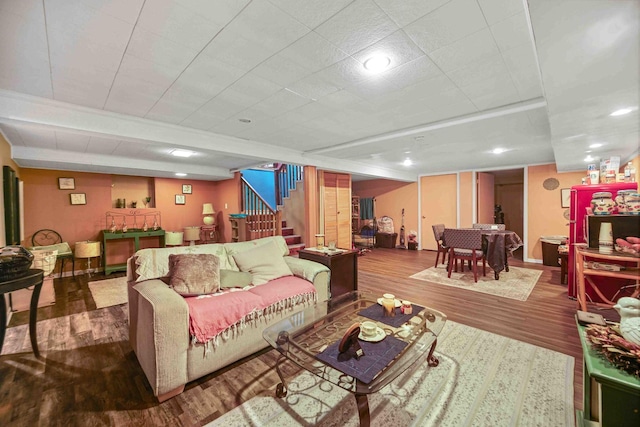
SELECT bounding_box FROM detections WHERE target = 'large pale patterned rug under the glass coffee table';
[208,321,574,427]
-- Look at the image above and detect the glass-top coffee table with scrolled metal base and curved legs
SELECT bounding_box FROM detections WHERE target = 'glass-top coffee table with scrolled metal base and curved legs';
[262,291,447,426]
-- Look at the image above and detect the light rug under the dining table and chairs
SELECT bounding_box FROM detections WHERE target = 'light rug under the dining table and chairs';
[410,265,542,301]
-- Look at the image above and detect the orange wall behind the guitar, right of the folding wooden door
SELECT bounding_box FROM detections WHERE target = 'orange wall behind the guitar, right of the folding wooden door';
[351,179,419,244]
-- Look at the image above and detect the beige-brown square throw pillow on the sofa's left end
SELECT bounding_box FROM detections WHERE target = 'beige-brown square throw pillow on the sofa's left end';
[169,254,220,296]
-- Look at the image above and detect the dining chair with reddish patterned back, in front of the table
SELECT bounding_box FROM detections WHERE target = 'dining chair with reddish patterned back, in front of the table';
[444,228,487,282]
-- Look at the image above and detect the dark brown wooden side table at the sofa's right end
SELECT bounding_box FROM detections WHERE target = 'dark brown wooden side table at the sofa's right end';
[298,249,358,298]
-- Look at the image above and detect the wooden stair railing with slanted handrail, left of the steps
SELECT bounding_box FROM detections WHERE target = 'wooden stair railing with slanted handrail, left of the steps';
[240,178,282,240]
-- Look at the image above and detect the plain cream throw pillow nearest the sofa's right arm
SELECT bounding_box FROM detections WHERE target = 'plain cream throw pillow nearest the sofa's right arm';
[233,242,293,285]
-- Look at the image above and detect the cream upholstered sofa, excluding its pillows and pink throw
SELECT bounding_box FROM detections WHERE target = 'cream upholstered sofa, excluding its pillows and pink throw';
[127,236,330,402]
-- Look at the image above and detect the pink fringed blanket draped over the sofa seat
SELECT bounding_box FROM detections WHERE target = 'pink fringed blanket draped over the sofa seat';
[185,276,316,347]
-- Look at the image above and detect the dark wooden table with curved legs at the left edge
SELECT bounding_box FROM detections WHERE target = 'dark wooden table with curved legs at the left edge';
[0,269,44,358]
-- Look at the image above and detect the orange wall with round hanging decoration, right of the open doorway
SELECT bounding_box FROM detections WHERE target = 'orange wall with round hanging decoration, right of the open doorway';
[525,164,586,260]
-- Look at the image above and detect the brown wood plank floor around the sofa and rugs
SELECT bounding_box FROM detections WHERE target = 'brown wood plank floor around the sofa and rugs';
[0,249,614,426]
